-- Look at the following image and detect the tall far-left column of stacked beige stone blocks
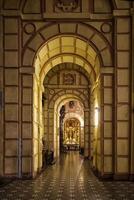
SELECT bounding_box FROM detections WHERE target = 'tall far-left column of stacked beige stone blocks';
[3,17,21,177]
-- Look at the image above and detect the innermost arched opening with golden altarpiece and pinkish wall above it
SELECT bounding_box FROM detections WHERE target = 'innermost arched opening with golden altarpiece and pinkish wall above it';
[62,100,84,155]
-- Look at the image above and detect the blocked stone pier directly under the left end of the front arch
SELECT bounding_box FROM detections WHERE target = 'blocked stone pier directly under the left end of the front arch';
[21,73,34,176]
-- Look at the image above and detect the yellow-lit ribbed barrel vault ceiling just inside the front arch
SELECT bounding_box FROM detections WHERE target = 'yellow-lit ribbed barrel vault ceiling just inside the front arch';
[34,35,100,84]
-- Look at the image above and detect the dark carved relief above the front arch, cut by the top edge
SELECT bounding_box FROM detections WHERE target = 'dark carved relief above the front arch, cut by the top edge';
[55,0,79,12]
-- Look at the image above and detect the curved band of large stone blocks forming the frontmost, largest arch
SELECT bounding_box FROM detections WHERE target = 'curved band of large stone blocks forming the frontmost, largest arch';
[23,23,112,66]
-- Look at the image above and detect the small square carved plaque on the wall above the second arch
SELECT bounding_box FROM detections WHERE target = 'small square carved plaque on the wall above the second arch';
[63,73,76,85]
